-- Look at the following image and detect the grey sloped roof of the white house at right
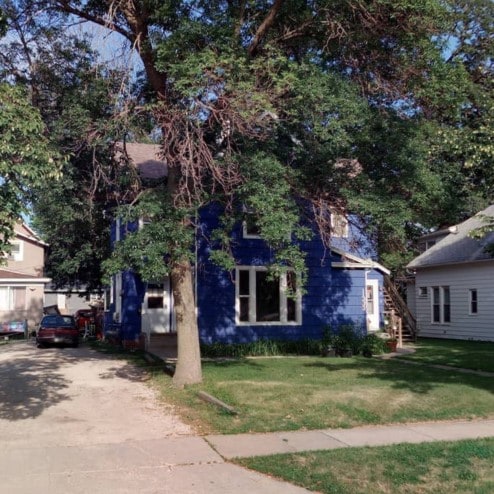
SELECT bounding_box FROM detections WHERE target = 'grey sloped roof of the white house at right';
[407,205,494,269]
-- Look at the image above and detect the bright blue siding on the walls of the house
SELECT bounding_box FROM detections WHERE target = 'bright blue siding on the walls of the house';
[112,207,383,343]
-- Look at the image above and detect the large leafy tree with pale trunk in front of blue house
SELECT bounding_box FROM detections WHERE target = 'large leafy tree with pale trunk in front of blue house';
[9,0,492,386]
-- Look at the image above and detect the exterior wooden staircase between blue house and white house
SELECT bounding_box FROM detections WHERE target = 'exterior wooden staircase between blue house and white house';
[384,276,417,342]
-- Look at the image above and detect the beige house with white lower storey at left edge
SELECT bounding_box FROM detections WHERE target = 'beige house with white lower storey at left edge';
[0,223,50,328]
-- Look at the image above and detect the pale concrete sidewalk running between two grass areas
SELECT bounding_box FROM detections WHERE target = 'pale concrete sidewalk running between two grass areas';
[205,419,494,459]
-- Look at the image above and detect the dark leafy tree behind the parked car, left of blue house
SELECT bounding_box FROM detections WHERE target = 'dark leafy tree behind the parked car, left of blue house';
[0,1,139,290]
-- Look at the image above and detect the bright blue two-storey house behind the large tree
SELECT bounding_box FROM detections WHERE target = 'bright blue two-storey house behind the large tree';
[109,144,389,350]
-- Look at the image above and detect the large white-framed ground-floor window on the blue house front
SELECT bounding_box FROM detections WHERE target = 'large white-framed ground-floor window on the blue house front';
[235,266,302,325]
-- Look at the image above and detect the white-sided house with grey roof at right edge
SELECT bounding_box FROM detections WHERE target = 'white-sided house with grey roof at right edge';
[407,206,494,341]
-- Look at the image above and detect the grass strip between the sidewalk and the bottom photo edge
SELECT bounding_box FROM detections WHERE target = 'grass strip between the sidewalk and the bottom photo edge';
[238,439,494,494]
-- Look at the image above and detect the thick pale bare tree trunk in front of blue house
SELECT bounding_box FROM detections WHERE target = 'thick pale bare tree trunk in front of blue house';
[171,260,202,388]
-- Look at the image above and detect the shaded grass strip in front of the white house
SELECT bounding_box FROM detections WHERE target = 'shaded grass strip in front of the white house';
[400,338,494,373]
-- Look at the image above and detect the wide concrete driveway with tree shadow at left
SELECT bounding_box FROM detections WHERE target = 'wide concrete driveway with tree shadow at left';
[0,343,307,494]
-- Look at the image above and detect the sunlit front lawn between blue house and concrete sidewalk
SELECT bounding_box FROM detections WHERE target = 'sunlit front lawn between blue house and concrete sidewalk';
[154,357,494,434]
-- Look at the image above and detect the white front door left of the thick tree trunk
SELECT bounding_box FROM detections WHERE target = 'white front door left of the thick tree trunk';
[142,277,171,335]
